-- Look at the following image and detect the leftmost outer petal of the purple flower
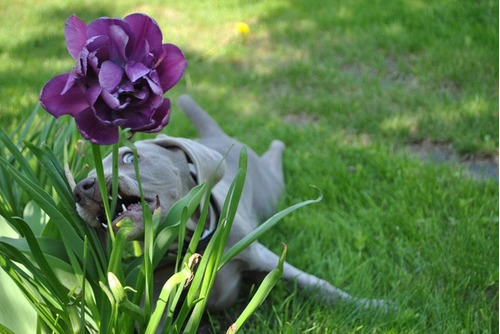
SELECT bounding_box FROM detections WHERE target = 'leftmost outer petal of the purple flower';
[40,73,89,117]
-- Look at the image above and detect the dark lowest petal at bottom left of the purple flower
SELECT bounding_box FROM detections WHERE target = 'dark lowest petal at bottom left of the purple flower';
[75,108,118,145]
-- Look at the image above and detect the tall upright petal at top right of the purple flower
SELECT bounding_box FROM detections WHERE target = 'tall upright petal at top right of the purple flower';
[123,13,163,61]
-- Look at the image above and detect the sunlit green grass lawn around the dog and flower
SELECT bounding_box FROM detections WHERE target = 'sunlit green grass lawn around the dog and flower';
[0,0,499,333]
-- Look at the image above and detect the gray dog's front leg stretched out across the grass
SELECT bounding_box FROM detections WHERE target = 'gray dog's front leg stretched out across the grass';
[240,242,388,312]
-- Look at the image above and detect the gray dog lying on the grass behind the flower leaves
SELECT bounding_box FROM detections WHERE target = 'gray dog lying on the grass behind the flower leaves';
[74,96,385,311]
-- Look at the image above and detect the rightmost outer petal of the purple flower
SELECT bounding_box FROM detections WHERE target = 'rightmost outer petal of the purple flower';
[156,44,186,92]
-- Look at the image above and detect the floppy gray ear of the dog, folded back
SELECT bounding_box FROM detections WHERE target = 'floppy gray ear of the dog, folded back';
[152,134,226,183]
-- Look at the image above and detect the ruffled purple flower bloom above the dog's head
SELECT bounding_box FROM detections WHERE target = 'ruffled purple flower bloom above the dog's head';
[40,14,186,144]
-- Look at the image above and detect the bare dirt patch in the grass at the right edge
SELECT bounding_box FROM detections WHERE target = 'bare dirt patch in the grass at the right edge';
[409,139,498,182]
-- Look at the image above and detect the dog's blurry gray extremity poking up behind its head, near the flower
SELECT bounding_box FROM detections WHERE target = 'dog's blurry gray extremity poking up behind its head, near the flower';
[179,95,224,138]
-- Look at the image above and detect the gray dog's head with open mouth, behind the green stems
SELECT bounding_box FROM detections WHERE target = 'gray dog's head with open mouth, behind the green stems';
[73,135,225,239]
